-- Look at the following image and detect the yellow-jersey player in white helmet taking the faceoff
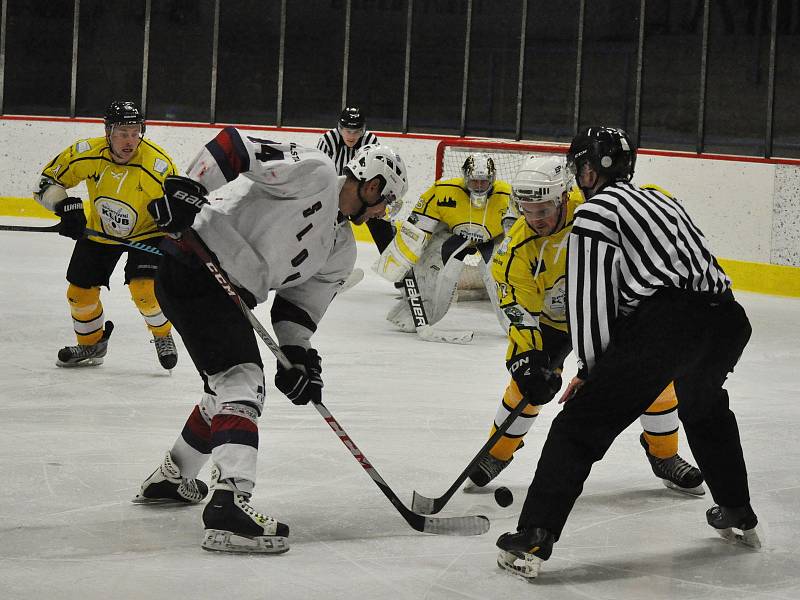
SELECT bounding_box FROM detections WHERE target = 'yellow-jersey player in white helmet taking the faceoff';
[465,156,705,495]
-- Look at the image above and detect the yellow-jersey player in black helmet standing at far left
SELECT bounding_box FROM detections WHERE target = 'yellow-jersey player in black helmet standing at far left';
[34,101,178,369]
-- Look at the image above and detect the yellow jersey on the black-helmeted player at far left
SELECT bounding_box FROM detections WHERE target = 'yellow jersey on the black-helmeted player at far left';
[42,137,178,244]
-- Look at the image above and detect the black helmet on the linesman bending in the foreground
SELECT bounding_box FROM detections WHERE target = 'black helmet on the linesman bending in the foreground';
[567,127,636,181]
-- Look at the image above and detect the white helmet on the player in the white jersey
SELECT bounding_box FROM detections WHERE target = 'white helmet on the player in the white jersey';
[345,144,408,217]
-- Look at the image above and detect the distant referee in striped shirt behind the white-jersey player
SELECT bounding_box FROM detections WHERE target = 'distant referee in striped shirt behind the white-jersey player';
[317,106,394,252]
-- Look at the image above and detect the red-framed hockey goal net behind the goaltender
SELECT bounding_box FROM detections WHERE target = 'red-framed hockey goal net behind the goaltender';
[436,139,569,292]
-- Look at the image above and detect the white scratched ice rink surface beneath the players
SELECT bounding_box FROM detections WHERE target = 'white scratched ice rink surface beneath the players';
[0,225,800,600]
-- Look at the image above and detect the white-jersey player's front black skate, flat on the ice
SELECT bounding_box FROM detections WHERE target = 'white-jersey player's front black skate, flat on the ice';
[202,480,289,554]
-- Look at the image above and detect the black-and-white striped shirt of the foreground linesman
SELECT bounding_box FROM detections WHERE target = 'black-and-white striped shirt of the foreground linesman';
[567,182,731,376]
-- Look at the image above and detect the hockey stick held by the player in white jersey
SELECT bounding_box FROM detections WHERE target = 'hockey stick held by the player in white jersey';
[181,229,489,535]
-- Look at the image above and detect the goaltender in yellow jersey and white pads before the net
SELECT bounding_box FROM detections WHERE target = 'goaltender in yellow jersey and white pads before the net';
[373,154,511,332]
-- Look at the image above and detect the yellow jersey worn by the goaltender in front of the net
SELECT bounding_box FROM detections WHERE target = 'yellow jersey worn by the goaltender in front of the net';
[408,177,511,244]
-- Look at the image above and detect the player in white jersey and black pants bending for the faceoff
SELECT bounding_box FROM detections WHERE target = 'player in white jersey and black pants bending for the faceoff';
[134,127,408,553]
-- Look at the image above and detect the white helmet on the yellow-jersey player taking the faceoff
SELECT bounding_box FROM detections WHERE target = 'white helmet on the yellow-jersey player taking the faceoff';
[511,154,572,219]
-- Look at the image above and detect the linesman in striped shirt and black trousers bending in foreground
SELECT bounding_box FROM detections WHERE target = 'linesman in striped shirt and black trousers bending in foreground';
[497,127,760,578]
